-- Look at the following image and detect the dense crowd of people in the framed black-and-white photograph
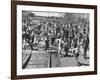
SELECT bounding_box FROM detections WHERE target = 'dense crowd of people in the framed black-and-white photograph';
[22,16,89,65]
